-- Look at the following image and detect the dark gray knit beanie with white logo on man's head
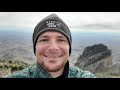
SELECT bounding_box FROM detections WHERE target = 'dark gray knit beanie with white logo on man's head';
[33,14,72,55]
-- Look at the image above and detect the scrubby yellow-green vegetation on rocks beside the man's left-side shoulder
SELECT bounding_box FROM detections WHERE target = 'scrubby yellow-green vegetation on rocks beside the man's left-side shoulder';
[0,59,30,77]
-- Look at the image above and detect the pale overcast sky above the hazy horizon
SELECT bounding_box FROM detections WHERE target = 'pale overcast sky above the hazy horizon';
[0,12,120,31]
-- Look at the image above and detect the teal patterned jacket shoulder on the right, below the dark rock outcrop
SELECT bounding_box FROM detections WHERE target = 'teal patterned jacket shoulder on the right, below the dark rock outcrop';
[69,66,96,78]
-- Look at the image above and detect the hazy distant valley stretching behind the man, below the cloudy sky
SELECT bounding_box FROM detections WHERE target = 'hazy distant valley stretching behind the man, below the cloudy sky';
[0,30,120,65]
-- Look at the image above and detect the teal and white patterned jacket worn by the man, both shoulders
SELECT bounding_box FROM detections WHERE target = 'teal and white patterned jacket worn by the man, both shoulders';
[8,63,96,78]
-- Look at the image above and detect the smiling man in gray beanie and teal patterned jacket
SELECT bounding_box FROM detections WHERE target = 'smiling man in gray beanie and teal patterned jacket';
[9,14,95,78]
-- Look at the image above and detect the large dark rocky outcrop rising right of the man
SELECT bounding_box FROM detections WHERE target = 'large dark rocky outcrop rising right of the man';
[75,44,112,72]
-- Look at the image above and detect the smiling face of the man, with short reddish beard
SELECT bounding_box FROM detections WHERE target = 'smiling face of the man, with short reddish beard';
[36,31,69,72]
